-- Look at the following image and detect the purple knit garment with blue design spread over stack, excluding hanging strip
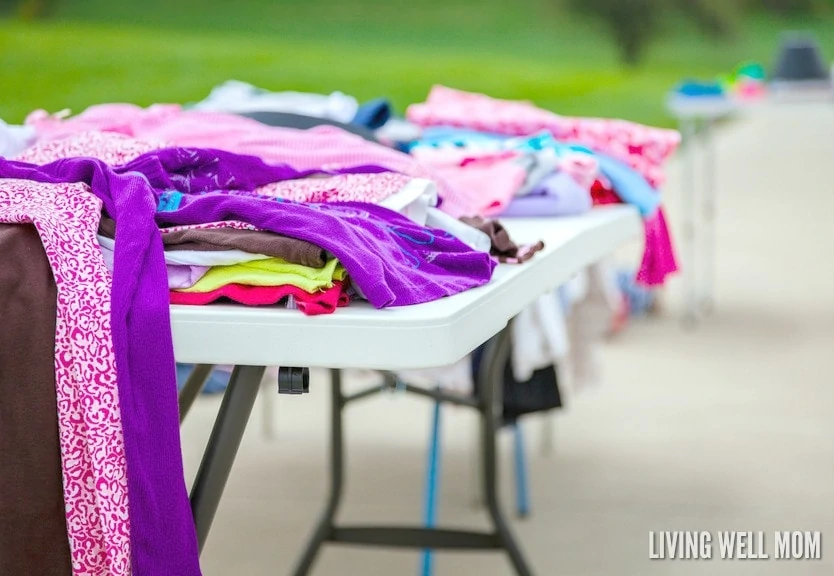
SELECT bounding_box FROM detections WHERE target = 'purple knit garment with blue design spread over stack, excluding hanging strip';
[117,148,495,308]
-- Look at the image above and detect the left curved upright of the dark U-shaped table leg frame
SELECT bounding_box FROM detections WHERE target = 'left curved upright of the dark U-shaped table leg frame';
[292,370,344,576]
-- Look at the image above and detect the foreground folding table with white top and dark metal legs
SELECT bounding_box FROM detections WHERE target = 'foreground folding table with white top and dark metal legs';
[171,206,643,576]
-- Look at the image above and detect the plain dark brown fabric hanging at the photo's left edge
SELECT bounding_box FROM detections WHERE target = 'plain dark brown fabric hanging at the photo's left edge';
[0,224,72,576]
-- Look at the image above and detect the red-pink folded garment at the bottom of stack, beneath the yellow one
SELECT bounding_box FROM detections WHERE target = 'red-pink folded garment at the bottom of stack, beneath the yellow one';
[171,280,350,316]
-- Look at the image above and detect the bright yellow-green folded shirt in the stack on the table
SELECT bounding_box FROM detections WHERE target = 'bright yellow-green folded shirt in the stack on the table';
[177,258,347,293]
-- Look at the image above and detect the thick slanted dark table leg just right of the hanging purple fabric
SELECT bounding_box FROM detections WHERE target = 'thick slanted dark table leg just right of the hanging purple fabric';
[191,366,266,551]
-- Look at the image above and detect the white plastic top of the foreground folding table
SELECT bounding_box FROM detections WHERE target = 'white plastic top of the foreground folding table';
[171,206,642,370]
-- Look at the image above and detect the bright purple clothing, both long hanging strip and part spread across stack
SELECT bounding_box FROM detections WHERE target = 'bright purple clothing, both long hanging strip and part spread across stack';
[0,149,495,576]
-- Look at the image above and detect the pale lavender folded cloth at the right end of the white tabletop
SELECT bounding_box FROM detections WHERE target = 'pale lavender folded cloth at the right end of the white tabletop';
[500,172,593,218]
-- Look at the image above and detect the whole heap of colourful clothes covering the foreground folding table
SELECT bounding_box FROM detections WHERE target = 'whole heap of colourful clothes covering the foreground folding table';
[0,82,679,576]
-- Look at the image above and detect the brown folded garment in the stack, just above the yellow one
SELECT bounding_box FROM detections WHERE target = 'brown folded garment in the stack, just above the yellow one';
[98,216,327,268]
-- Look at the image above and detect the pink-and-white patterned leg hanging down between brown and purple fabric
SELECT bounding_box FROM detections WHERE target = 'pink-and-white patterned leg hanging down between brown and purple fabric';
[0,179,130,576]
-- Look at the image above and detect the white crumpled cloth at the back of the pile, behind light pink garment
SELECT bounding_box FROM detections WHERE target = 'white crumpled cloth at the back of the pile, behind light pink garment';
[194,80,359,124]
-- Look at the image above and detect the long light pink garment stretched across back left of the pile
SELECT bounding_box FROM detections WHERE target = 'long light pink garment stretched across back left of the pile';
[26,104,450,196]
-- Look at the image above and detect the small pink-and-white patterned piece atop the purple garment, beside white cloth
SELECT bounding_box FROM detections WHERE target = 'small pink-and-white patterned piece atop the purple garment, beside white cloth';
[255,172,412,204]
